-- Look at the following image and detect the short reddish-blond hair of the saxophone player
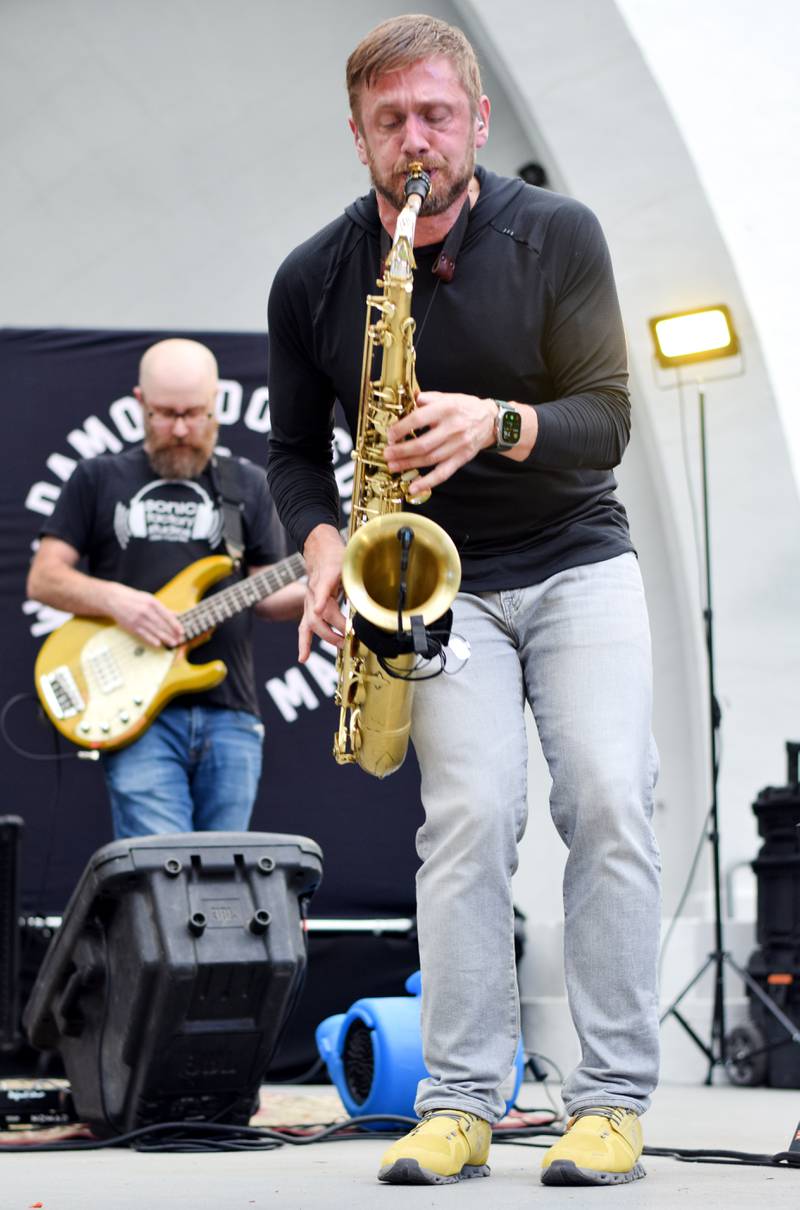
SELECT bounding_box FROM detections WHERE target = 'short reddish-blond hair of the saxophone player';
[346,13,483,122]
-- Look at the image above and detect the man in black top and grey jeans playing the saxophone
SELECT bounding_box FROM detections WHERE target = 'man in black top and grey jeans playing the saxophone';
[269,15,660,1185]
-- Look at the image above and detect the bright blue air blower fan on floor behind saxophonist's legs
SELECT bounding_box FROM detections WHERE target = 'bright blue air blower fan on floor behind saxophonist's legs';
[316,970,525,1129]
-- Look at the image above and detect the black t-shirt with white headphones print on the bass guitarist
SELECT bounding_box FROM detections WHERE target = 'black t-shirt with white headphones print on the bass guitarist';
[41,446,286,714]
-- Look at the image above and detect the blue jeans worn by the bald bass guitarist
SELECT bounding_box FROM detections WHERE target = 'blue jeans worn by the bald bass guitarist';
[103,705,264,839]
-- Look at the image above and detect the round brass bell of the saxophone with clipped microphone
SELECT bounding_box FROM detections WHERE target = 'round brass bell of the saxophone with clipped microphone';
[341,512,461,632]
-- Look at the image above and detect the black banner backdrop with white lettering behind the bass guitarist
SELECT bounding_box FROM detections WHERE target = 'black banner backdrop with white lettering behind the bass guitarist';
[0,328,422,919]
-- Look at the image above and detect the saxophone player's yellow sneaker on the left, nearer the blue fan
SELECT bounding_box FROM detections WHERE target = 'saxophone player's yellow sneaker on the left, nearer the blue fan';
[378,1110,491,1185]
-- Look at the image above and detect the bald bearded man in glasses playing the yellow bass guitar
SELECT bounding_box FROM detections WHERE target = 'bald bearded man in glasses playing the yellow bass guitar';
[28,339,304,837]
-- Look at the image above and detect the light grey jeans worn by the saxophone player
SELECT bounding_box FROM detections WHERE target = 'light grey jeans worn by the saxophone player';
[411,554,661,1122]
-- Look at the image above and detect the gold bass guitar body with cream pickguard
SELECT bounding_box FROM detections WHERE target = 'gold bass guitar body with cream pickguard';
[34,554,234,749]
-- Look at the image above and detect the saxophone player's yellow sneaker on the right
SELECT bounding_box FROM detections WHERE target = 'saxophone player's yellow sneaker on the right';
[542,1105,645,1185]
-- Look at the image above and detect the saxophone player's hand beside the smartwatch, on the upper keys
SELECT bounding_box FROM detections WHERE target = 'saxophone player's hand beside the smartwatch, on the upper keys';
[386,391,497,495]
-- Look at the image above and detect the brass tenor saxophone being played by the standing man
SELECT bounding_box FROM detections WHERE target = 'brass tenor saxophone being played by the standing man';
[333,162,461,777]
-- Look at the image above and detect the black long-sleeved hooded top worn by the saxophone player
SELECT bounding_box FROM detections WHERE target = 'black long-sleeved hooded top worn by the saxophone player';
[267,168,632,592]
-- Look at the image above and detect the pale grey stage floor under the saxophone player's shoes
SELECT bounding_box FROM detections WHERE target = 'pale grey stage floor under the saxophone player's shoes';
[0,1084,800,1210]
